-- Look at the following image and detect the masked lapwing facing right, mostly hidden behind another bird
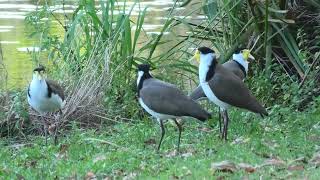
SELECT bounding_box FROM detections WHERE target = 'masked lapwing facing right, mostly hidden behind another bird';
[189,48,255,132]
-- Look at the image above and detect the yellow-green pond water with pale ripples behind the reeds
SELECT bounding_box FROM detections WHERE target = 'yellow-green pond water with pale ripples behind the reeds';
[0,0,204,89]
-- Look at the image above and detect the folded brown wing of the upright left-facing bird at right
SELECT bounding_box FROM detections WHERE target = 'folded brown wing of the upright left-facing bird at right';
[209,65,267,115]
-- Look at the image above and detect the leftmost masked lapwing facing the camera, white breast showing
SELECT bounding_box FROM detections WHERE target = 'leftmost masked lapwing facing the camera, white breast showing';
[28,65,65,144]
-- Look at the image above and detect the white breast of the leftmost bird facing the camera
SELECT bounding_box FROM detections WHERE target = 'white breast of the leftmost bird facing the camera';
[28,79,64,114]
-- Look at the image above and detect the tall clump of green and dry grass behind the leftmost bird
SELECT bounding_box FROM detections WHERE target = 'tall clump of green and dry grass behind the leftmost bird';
[1,0,165,138]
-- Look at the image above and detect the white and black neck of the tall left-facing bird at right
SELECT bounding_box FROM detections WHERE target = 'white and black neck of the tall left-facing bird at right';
[199,54,217,83]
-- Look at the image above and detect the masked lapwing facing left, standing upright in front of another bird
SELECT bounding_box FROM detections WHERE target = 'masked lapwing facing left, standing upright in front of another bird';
[194,47,268,140]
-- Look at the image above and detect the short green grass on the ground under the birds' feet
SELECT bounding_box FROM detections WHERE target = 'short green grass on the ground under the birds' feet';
[0,109,320,179]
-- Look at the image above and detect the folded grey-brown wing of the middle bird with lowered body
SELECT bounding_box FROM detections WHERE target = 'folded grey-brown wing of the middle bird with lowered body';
[140,79,210,120]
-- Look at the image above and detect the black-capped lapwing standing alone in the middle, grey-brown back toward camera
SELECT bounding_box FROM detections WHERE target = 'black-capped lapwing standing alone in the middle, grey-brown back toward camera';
[137,64,211,151]
